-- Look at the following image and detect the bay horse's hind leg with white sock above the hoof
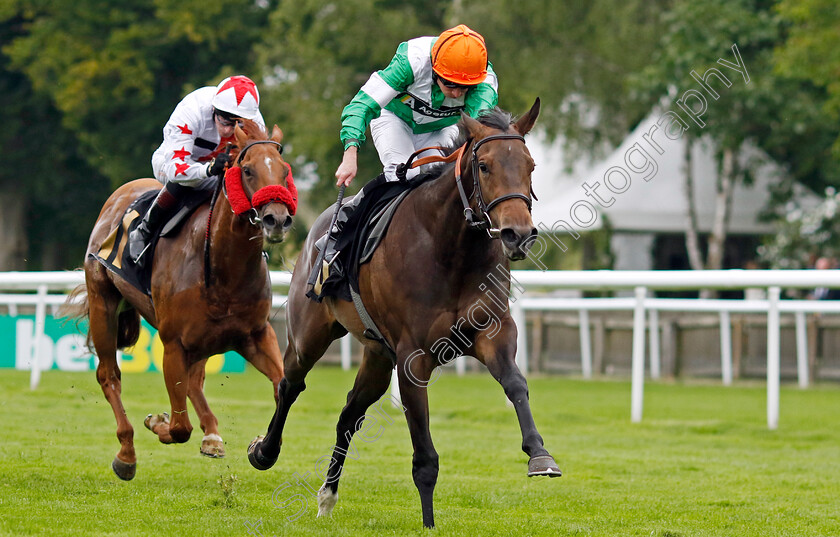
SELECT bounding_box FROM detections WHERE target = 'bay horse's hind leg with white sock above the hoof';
[318,349,393,516]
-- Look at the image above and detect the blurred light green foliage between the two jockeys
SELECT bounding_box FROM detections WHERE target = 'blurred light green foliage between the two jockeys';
[257,0,446,207]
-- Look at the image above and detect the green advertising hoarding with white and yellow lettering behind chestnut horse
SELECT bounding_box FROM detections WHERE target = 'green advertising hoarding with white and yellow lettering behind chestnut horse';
[0,315,245,373]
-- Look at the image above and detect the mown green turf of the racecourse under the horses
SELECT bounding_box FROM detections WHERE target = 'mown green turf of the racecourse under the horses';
[0,367,840,537]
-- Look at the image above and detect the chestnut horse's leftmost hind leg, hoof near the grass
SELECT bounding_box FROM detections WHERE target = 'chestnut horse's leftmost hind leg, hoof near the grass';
[87,267,139,481]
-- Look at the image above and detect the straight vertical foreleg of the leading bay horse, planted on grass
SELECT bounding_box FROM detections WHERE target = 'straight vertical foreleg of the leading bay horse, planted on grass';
[397,348,439,528]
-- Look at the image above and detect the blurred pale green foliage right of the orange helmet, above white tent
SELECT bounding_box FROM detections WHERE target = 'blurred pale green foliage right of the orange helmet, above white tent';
[450,0,671,157]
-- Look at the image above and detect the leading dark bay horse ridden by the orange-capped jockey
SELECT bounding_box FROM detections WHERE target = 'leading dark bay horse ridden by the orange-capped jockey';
[248,99,560,527]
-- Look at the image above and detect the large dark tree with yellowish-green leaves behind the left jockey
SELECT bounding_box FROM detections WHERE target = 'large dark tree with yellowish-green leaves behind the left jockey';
[0,0,280,268]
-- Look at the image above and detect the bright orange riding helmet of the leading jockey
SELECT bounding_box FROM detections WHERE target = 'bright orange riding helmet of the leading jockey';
[432,24,487,86]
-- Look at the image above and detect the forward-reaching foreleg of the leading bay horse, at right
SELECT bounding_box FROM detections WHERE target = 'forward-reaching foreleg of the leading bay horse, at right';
[475,318,562,477]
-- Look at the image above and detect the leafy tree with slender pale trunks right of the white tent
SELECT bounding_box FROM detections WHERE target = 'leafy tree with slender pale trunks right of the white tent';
[636,0,803,270]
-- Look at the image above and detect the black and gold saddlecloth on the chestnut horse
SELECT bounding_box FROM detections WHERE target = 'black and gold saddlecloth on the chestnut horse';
[90,188,213,296]
